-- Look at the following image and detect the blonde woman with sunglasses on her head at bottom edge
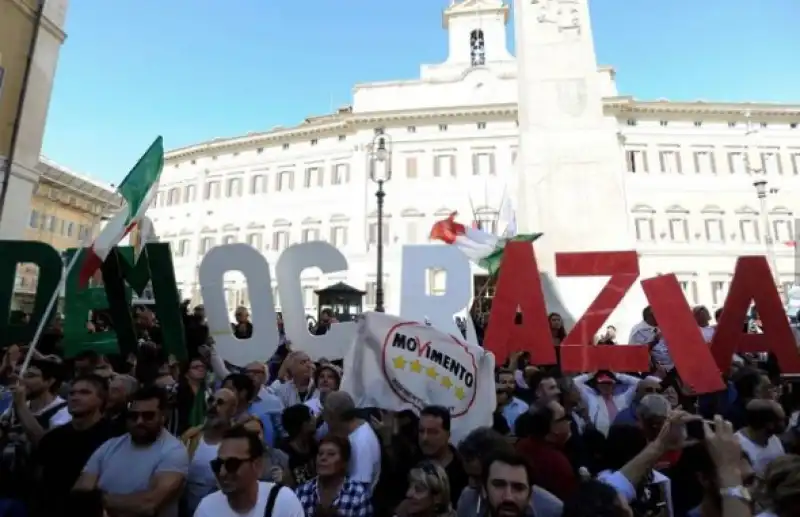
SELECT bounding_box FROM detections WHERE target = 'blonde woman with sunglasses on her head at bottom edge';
[395,461,456,517]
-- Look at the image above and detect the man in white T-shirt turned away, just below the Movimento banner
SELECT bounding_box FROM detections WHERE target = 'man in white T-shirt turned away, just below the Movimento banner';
[322,391,381,489]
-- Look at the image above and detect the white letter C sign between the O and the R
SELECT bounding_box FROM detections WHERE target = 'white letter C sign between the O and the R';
[273,241,357,359]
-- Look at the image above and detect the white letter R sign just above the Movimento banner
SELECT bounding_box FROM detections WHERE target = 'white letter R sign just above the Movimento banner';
[400,245,478,345]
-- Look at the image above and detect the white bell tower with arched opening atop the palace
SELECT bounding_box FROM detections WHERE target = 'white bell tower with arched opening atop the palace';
[442,0,513,67]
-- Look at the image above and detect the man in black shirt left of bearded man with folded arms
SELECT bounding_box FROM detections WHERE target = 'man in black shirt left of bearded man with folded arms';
[32,374,113,517]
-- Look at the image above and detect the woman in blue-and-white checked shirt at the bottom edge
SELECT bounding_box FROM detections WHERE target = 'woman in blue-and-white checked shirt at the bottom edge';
[297,435,373,517]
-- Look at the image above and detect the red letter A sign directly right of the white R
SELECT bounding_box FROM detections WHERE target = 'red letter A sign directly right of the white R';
[484,242,557,364]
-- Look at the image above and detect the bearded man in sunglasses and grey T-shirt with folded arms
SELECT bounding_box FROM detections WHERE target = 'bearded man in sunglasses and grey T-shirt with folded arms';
[73,385,189,517]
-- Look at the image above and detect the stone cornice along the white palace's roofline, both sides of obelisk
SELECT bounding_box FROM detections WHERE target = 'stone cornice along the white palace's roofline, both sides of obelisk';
[166,97,800,163]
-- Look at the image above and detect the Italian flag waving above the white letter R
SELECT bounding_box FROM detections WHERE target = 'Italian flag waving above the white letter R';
[430,213,542,275]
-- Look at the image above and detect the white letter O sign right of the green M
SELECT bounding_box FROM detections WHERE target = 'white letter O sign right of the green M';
[200,244,278,366]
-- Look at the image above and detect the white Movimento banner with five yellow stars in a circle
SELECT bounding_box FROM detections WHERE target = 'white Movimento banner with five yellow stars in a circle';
[341,312,496,442]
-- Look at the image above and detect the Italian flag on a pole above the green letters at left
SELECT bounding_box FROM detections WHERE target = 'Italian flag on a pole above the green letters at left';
[78,137,164,287]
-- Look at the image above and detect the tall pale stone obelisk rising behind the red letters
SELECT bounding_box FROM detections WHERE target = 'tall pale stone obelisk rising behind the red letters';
[514,0,646,339]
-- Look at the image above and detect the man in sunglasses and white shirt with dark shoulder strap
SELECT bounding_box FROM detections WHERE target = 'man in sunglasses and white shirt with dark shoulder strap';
[194,427,305,517]
